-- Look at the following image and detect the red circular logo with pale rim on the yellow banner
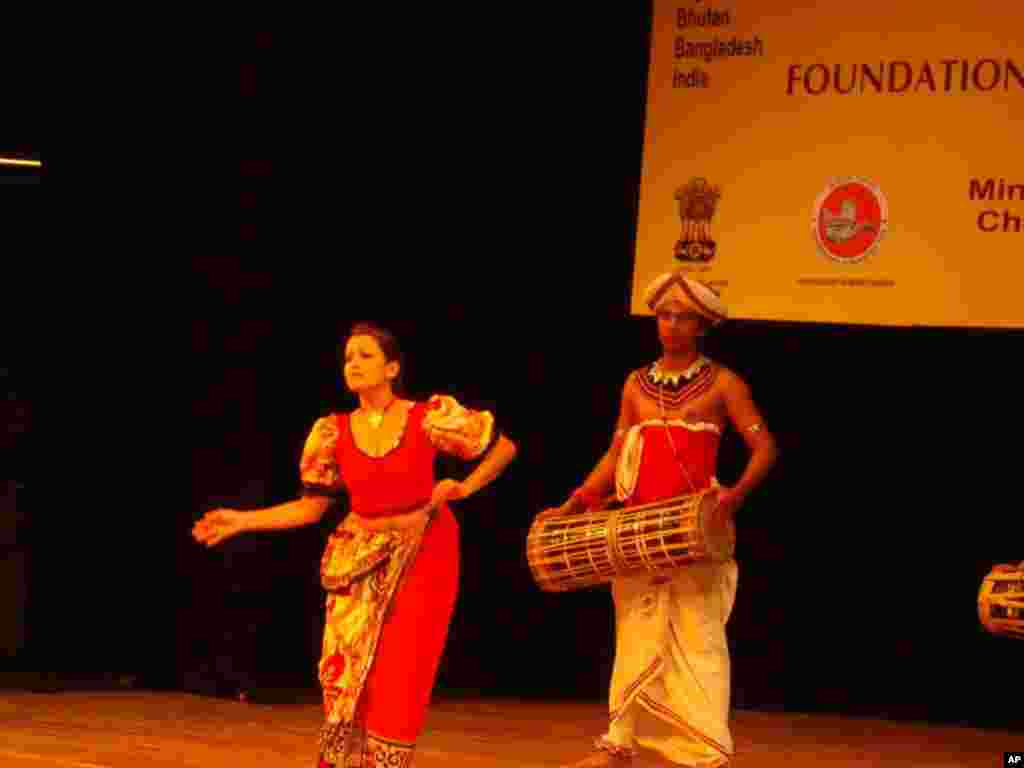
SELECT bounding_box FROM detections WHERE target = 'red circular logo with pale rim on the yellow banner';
[812,177,889,264]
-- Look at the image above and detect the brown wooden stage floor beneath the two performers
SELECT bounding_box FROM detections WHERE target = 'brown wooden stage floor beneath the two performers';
[0,691,1011,768]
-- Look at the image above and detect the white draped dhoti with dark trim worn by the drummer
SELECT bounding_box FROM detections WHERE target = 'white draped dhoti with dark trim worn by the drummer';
[602,560,738,768]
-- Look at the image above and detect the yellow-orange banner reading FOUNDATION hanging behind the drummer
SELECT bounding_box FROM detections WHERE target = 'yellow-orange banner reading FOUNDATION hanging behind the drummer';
[632,0,1024,328]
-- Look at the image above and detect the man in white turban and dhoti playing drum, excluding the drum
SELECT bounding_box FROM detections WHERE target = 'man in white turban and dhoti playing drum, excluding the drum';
[544,272,777,768]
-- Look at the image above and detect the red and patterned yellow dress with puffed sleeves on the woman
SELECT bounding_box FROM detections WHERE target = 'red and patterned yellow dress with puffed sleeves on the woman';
[301,396,494,768]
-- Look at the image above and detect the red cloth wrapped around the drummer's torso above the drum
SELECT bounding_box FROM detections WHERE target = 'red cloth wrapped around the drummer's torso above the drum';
[627,425,721,505]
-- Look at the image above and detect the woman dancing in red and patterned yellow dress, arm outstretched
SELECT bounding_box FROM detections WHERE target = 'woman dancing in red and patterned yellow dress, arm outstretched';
[194,324,516,768]
